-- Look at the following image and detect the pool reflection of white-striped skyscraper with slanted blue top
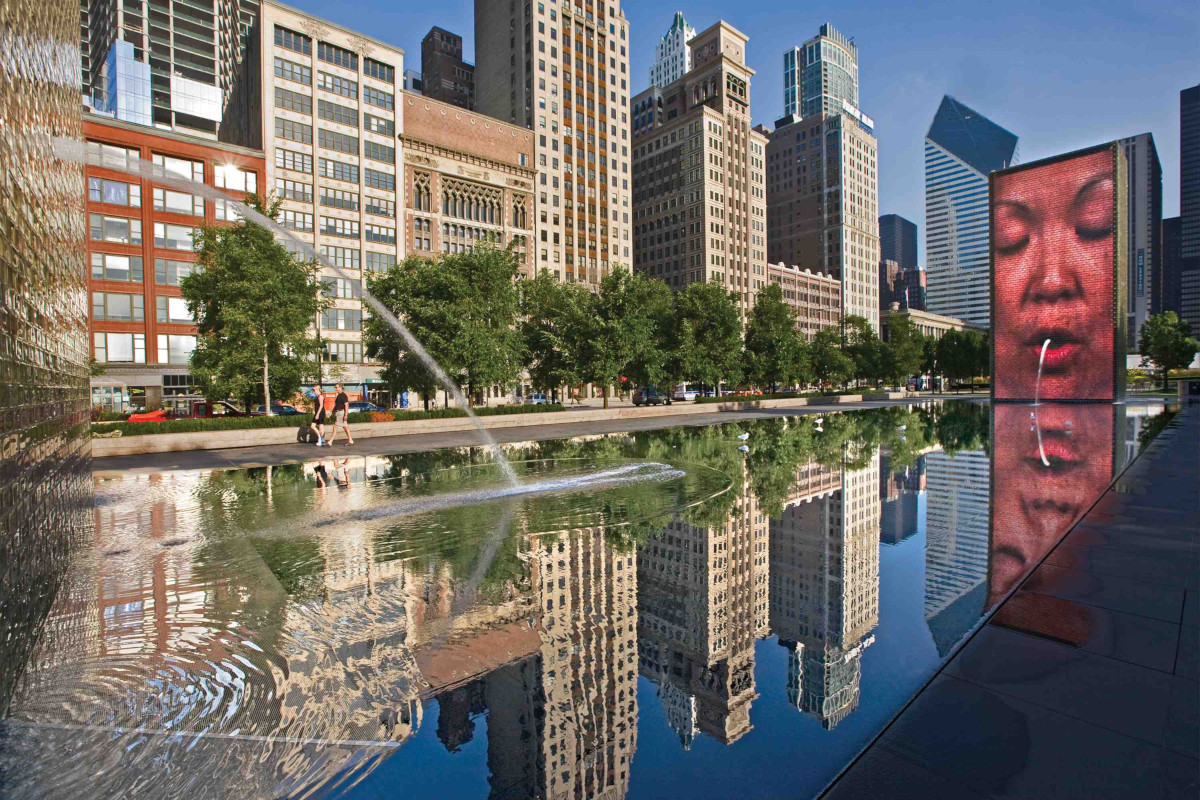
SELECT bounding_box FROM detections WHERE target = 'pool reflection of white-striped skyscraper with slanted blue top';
[925,451,990,656]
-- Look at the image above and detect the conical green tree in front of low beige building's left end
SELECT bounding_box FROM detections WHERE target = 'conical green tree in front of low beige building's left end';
[745,283,810,391]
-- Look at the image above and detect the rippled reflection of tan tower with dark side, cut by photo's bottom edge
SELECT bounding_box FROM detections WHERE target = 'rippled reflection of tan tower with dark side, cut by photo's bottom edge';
[438,529,637,800]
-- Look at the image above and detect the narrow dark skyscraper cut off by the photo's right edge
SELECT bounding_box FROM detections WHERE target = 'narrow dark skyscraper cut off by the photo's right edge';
[1178,84,1200,336]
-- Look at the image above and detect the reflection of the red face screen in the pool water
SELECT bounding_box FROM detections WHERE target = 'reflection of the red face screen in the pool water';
[988,404,1121,633]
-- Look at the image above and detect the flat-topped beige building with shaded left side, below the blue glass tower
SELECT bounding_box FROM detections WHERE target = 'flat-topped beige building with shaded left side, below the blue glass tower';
[767,109,880,331]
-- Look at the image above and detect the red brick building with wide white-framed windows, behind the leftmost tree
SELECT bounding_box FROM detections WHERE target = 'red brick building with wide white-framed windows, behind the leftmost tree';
[83,114,266,411]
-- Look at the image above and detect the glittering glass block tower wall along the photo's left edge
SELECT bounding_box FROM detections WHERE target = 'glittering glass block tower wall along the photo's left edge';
[0,0,91,716]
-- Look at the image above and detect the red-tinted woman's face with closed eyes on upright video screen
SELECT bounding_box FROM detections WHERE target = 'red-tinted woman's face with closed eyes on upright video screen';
[992,150,1115,399]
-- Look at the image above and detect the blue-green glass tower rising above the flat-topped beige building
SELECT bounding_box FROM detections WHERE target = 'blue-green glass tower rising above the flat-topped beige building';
[784,23,858,118]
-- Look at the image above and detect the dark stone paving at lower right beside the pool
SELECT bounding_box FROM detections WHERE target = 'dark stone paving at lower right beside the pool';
[823,405,1200,800]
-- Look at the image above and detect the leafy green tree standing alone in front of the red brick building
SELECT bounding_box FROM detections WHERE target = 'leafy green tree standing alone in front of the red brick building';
[180,196,325,413]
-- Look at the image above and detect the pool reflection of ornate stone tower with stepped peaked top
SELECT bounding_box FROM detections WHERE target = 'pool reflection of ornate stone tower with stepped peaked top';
[637,472,769,746]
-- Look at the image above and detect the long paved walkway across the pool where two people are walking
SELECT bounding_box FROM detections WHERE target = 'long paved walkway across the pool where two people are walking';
[92,395,986,477]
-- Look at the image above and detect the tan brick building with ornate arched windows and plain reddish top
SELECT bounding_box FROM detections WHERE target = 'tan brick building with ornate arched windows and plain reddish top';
[401,92,538,275]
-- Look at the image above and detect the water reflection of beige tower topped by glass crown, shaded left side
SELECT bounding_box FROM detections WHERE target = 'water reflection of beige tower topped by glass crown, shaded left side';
[770,453,880,728]
